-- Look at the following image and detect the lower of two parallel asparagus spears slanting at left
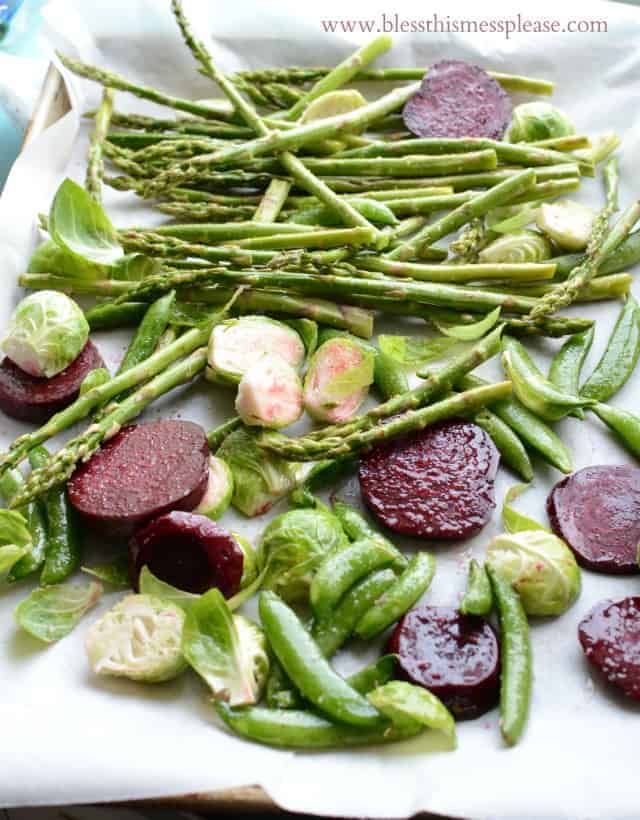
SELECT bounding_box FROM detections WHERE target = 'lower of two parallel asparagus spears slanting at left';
[11,347,207,507]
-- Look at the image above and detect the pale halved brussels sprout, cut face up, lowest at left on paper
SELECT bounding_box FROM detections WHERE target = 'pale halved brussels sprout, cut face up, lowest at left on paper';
[85,595,186,683]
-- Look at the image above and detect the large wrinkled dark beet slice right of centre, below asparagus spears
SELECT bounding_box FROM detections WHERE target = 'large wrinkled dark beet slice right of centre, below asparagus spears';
[359,420,499,539]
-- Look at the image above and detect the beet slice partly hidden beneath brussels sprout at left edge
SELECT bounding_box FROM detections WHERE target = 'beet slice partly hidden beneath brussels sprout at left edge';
[0,339,104,424]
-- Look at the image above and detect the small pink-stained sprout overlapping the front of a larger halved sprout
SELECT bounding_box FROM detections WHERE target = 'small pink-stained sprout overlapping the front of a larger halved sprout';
[236,353,302,430]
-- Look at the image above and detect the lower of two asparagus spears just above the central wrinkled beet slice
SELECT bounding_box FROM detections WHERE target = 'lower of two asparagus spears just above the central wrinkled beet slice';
[258,382,511,461]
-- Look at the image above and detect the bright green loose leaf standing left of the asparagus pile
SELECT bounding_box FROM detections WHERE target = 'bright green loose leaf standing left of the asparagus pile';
[49,179,124,265]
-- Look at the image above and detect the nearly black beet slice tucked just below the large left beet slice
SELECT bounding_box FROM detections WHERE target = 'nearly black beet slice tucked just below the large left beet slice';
[129,512,244,598]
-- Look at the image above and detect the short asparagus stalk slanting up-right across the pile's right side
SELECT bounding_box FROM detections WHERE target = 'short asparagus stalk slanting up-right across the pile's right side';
[388,169,536,261]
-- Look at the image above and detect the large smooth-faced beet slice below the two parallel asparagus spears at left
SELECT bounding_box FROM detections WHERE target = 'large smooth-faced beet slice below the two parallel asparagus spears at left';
[68,420,209,536]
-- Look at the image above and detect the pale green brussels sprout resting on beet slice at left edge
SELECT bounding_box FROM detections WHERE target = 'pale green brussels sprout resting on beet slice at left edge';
[2,290,89,379]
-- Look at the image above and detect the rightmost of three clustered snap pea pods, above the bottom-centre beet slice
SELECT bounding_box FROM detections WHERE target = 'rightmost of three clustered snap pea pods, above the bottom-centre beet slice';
[356,552,436,640]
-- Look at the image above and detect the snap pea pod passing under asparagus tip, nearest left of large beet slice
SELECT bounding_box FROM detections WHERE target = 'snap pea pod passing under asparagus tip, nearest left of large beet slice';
[31,447,80,586]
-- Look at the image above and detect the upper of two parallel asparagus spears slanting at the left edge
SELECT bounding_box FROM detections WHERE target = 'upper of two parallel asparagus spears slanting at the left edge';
[0,327,211,475]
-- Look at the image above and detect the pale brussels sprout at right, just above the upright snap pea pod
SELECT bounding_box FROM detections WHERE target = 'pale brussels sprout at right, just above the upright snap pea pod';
[487,530,581,615]
